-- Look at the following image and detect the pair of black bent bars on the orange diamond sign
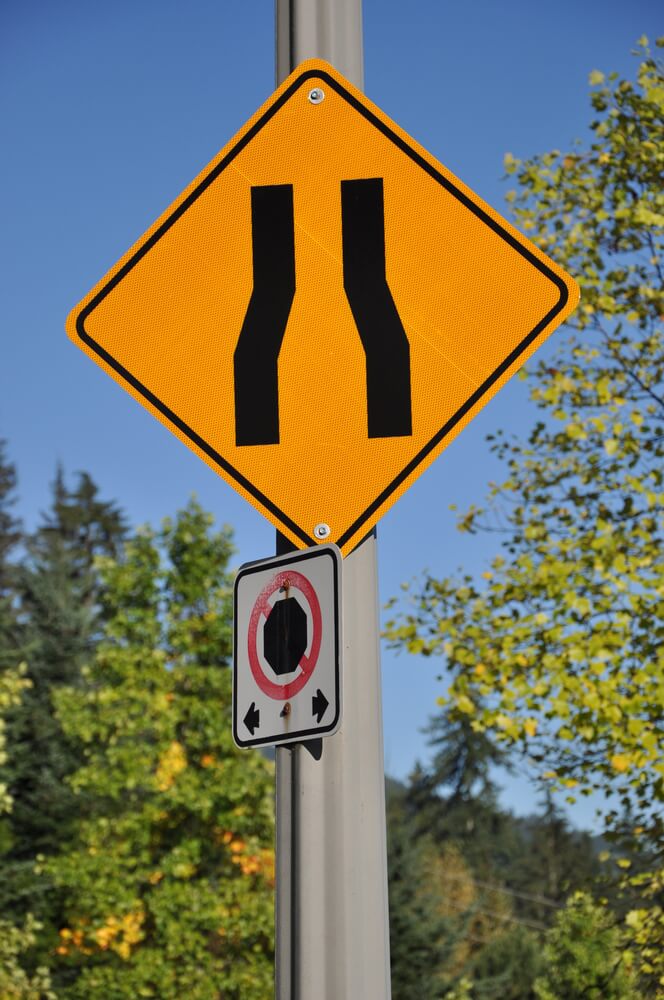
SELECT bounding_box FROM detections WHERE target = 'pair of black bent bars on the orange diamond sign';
[234,177,412,446]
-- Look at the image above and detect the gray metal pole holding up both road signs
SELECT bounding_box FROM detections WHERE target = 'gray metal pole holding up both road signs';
[275,0,391,1000]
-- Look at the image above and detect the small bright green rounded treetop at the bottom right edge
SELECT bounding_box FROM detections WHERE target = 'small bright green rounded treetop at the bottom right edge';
[535,893,640,1000]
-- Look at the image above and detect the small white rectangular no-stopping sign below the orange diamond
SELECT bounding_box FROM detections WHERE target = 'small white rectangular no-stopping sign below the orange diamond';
[233,545,342,747]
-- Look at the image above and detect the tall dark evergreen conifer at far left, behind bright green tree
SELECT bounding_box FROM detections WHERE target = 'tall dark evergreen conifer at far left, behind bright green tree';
[0,469,125,936]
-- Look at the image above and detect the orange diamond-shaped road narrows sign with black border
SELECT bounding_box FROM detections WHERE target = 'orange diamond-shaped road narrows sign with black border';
[67,60,578,553]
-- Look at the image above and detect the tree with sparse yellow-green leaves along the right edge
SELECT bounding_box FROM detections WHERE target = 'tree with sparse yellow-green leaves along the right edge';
[388,39,664,989]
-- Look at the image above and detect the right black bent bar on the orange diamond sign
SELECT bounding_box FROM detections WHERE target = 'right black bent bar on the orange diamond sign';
[341,177,413,438]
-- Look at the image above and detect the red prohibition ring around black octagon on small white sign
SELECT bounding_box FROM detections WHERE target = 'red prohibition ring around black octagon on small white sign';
[247,569,323,701]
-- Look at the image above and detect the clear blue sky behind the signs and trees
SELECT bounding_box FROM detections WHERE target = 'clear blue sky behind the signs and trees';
[0,0,662,822]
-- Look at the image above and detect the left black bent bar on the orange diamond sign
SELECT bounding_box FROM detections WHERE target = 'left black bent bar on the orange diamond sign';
[233,184,295,446]
